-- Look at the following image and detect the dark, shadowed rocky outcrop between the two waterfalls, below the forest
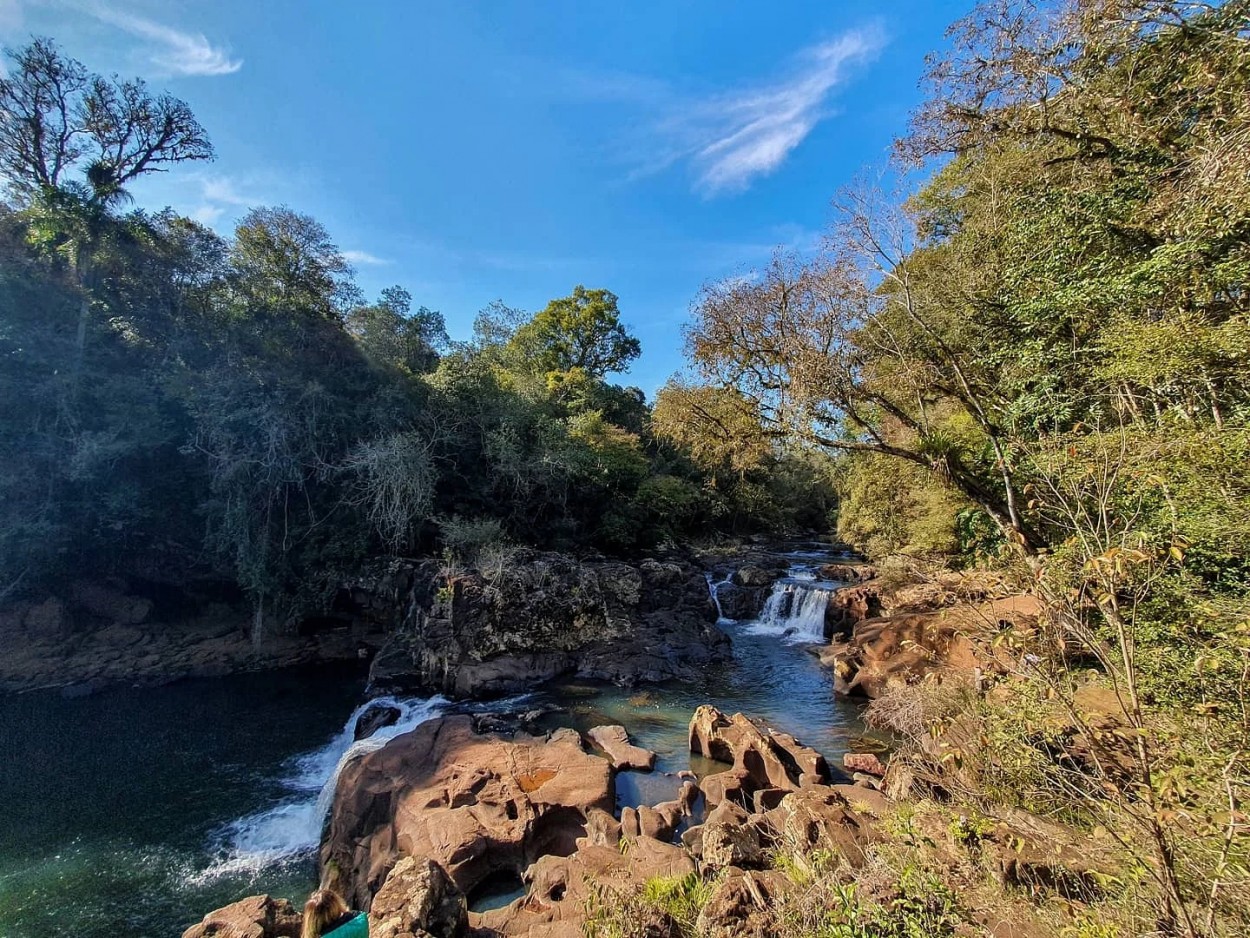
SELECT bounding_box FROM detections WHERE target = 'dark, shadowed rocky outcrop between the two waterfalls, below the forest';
[371,552,729,698]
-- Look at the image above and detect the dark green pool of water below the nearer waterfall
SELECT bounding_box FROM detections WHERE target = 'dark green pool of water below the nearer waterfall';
[0,669,364,938]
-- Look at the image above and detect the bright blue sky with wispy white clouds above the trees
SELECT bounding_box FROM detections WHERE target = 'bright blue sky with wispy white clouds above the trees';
[0,0,970,394]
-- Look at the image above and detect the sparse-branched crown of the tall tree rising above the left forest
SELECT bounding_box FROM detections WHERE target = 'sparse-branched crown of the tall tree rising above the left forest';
[0,39,213,204]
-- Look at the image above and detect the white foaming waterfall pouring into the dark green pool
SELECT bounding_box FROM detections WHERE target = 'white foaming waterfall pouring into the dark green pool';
[195,697,448,880]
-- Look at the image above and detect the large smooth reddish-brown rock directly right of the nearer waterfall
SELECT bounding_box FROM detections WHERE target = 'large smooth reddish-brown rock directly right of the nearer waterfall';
[321,715,614,909]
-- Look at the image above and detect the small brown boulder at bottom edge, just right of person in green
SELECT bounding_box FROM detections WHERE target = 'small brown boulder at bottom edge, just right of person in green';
[369,857,469,938]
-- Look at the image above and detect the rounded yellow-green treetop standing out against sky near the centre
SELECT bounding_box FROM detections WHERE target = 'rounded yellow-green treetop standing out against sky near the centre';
[510,285,643,379]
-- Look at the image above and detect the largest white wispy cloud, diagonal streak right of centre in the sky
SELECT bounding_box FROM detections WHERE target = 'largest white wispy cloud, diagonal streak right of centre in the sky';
[618,28,885,196]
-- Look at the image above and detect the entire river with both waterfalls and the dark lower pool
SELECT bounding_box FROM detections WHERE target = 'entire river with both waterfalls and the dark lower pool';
[0,545,864,938]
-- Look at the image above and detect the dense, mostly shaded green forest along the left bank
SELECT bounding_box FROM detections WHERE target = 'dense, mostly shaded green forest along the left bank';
[0,40,833,628]
